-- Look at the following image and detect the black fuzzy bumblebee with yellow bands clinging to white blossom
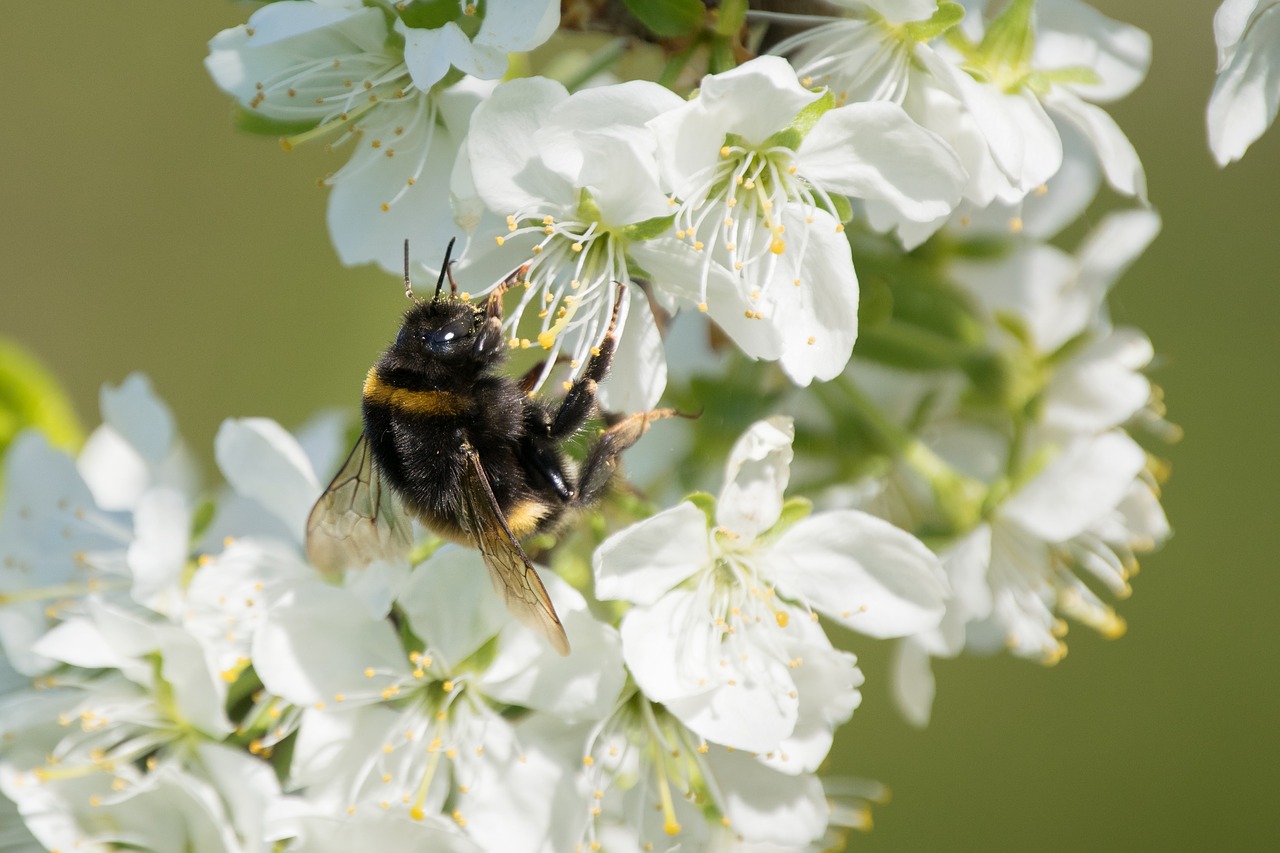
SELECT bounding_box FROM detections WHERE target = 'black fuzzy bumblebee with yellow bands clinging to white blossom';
[306,241,675,654]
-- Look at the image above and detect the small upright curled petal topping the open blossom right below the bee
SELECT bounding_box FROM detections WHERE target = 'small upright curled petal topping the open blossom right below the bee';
[716,415,795,542]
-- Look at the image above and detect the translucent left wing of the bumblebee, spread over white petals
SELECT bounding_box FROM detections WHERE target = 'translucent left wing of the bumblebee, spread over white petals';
[306,434,413,575]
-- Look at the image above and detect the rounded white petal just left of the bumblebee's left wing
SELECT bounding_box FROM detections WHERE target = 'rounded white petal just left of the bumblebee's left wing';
[214,418,320,542]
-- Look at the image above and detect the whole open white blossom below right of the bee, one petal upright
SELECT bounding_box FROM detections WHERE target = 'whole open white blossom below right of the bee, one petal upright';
[595,418,945,753]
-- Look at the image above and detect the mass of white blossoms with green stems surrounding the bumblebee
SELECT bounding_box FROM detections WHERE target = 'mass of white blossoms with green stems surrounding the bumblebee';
[0,0,1187,853]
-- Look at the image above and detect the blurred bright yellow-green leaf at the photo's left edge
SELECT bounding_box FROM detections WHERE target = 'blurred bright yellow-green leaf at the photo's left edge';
[0,338,84,456]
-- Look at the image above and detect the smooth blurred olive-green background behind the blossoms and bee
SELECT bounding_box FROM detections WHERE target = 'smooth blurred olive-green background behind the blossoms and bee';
[0,0,1280,850]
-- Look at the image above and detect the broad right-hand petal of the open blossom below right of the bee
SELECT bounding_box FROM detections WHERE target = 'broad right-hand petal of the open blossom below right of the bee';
[771,510,947,638]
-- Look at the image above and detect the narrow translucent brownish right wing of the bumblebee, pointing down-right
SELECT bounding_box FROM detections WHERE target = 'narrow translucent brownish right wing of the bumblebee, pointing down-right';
[462,444,568,654]
